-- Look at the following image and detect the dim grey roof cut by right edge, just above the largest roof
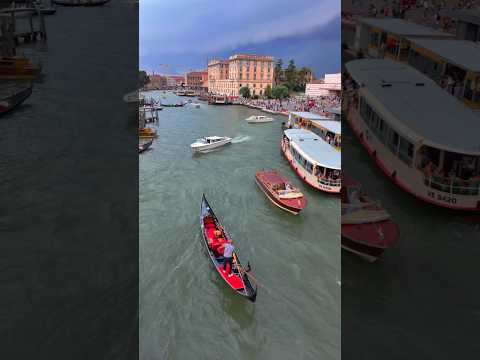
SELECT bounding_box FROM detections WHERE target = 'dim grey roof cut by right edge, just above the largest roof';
[409,38,480,72]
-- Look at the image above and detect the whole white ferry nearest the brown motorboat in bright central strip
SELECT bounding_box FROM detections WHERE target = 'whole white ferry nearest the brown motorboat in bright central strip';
[281,129,342,193]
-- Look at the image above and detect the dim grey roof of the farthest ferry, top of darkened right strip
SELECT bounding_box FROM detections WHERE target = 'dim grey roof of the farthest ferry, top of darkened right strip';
[359,18,453,38]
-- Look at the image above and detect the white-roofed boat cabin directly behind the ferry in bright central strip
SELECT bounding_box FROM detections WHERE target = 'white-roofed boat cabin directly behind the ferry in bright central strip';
[289,111,342,150]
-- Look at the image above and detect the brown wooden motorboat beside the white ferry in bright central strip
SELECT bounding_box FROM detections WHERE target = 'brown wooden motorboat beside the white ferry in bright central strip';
[255,170,307,215]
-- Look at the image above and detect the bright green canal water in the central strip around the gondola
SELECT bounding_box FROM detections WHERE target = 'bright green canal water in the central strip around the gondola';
[139,91,341,360]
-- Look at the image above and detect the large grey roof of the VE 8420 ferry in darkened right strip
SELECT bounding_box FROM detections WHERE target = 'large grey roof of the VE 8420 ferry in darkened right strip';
[346,59,480,155]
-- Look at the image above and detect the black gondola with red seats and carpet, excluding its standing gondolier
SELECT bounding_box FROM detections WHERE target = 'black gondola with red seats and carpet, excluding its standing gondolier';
[200,194,257,302]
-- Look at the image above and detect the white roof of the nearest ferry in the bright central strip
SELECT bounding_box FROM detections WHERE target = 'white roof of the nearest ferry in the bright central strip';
[284,129,342,170]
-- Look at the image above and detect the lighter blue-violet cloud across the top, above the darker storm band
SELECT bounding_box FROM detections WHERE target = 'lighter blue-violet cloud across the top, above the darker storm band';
[140,0,340,57]
